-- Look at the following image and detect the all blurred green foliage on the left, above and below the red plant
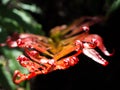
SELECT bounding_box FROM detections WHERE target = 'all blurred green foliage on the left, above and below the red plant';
[0,0,44,90]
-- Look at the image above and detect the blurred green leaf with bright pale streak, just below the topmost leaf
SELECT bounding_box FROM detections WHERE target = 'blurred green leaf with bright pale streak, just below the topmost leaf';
[0,5,43,35]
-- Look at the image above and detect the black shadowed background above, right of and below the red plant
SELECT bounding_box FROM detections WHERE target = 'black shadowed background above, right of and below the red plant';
[25,0,120,90]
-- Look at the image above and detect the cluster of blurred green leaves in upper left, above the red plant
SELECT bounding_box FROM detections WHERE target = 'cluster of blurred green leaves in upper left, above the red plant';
[0,0,44,35]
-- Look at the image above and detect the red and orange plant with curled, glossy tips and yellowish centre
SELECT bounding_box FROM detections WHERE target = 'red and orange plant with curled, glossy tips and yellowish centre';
[1,16,113,84]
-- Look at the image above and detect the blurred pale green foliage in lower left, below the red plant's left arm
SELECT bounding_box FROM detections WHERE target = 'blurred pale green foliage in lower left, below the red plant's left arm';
[0,47,29,90]
